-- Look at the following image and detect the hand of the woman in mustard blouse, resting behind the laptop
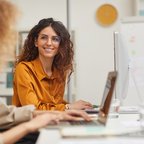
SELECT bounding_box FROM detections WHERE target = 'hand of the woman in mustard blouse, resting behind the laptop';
[68,100,93,110]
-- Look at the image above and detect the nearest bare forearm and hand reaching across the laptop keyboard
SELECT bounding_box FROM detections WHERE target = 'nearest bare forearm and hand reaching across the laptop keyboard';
[0,110,91,144]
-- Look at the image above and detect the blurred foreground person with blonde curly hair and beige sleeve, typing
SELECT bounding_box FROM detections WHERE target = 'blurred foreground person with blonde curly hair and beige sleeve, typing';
[0,0,90,144]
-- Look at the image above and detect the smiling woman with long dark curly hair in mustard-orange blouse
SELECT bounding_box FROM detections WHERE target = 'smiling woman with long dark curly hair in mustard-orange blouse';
[13,18,92,111]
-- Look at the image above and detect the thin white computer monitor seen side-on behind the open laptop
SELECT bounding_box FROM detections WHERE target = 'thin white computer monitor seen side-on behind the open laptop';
[114,32,129,105]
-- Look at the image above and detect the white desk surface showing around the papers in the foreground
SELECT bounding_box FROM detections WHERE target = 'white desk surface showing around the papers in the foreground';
[36,114,144,144]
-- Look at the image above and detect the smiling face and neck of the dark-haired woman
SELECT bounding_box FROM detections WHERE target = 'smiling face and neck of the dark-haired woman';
[35,26,61,66]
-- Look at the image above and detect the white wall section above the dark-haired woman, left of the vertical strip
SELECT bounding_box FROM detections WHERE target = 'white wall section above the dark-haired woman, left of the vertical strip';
[11,0,67,30]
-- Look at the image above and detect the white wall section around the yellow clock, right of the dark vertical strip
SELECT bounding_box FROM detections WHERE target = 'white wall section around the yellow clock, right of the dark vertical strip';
[69,0,133,104]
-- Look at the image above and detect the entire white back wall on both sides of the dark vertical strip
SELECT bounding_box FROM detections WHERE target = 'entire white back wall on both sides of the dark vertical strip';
[1,0,141,104]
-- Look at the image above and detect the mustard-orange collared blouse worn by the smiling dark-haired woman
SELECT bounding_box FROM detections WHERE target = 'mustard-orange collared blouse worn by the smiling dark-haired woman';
[12,58,67,110]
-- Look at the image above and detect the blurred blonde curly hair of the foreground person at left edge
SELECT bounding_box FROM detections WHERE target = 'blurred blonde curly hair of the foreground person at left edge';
[0,0,18,66]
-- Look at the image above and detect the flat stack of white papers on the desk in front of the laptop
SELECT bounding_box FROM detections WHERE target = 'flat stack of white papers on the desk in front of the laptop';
[60,127,139,138]
